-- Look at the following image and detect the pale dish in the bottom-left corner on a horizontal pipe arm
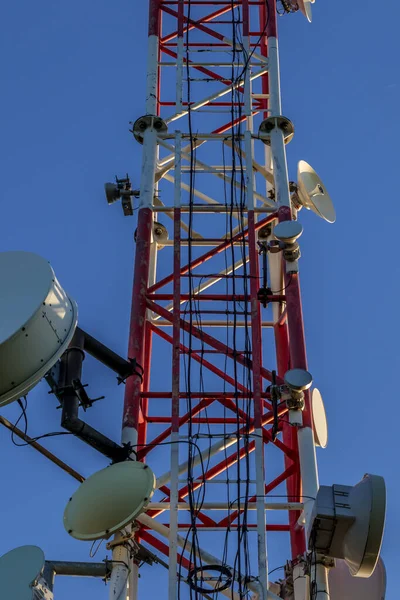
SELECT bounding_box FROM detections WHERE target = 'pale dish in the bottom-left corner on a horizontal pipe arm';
[0,546,45,600]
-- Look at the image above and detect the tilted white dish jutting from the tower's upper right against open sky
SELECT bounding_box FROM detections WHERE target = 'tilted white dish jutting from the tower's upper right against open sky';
[297,160,336,223]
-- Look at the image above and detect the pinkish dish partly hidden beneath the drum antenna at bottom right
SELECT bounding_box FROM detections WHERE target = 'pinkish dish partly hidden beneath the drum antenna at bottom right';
[329,558,386,600]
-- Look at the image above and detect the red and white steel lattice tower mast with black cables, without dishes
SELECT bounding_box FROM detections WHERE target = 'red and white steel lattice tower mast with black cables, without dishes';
[117,0,329,600]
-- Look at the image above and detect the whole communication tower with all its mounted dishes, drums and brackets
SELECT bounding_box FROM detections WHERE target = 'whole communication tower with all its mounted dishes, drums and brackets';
[0,0,385,600]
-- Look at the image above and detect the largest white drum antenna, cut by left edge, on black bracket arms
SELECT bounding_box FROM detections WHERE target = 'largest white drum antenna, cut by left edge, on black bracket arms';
[0,252,78,406]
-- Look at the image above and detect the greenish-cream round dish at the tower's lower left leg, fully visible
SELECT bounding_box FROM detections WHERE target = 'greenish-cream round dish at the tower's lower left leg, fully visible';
[64,461,155,540]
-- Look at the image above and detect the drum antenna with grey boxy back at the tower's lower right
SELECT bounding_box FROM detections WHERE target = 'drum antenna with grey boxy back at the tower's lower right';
[309,475,386,577]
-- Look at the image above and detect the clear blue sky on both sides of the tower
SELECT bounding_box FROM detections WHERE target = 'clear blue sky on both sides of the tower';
[0,0,400,600]
